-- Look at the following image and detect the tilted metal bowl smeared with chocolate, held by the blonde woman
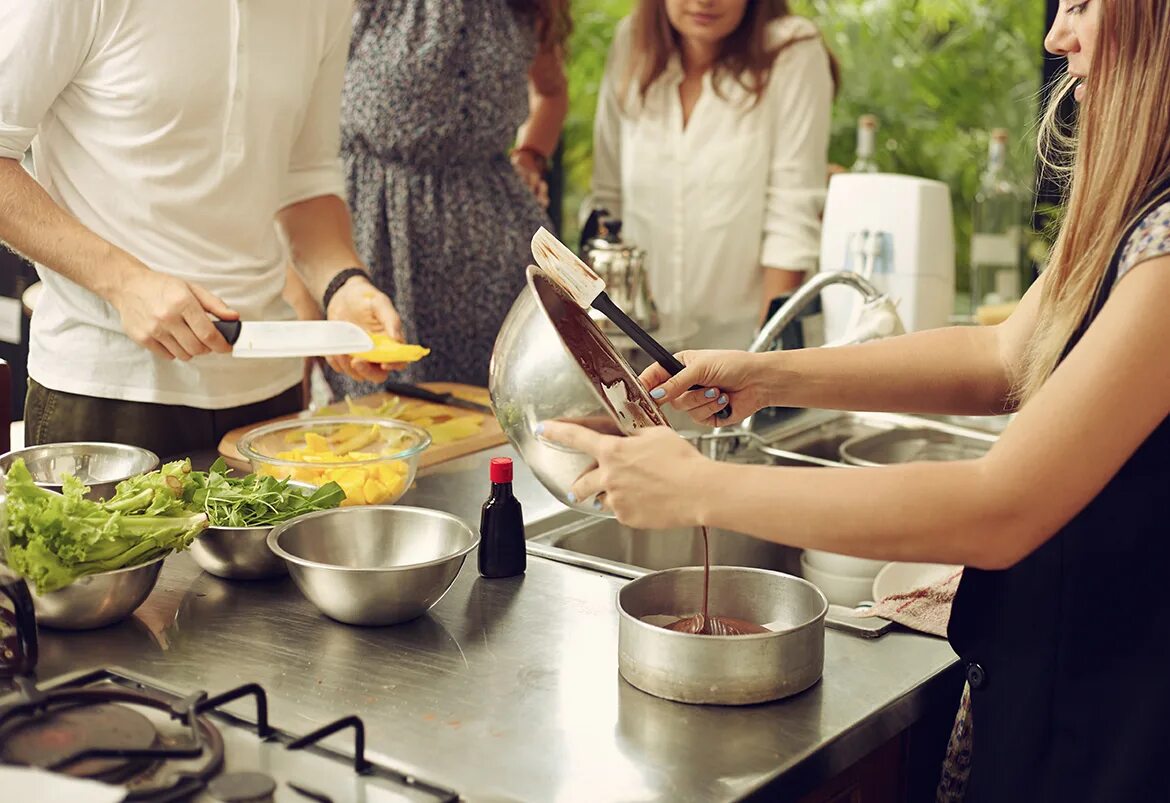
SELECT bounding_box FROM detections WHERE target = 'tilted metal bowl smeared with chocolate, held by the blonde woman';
[488,266,667,513]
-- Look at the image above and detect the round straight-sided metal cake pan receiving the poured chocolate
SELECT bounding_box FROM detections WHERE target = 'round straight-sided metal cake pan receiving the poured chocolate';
[618,567,828,706]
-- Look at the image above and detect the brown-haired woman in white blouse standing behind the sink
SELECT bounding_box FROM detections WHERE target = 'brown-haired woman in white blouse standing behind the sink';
[591,0,837,348]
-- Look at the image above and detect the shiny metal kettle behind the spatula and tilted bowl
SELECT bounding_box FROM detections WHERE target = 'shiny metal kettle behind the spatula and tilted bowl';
[581,214,659,334]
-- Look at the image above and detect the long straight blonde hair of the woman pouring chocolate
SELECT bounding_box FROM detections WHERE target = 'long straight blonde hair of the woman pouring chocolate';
[1013,0,1170,404]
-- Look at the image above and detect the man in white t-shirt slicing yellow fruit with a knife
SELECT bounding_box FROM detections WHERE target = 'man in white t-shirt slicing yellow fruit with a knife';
[0,0,401,457]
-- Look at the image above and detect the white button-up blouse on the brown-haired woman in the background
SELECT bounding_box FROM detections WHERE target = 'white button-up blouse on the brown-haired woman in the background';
[590,16,833,348]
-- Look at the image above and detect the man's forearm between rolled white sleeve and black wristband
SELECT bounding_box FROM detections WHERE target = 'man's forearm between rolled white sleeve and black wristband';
[278,195,363,303]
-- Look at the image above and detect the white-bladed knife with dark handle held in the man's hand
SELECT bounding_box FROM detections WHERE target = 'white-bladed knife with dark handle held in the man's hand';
[213,321,373,359]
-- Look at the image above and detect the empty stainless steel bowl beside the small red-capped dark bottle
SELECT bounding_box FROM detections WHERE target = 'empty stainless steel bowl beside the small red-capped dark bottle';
[268,506,480,625]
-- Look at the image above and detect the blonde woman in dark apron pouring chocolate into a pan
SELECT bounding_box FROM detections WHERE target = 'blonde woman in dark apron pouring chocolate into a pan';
[544,0,1170,803]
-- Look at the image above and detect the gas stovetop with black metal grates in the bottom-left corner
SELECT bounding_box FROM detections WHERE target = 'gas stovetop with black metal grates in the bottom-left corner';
[0,670,460,803]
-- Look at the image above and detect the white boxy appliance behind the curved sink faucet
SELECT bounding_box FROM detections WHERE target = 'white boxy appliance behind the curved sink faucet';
[820,173,955,343]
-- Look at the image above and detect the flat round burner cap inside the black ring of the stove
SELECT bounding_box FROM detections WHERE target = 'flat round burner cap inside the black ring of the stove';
[0,704,158,783]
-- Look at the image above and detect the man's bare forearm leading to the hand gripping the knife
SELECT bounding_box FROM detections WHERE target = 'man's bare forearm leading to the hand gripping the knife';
[0,158,145,300]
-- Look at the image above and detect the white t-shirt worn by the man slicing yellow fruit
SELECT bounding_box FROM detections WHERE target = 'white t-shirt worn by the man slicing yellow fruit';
[0,0,352,409]
